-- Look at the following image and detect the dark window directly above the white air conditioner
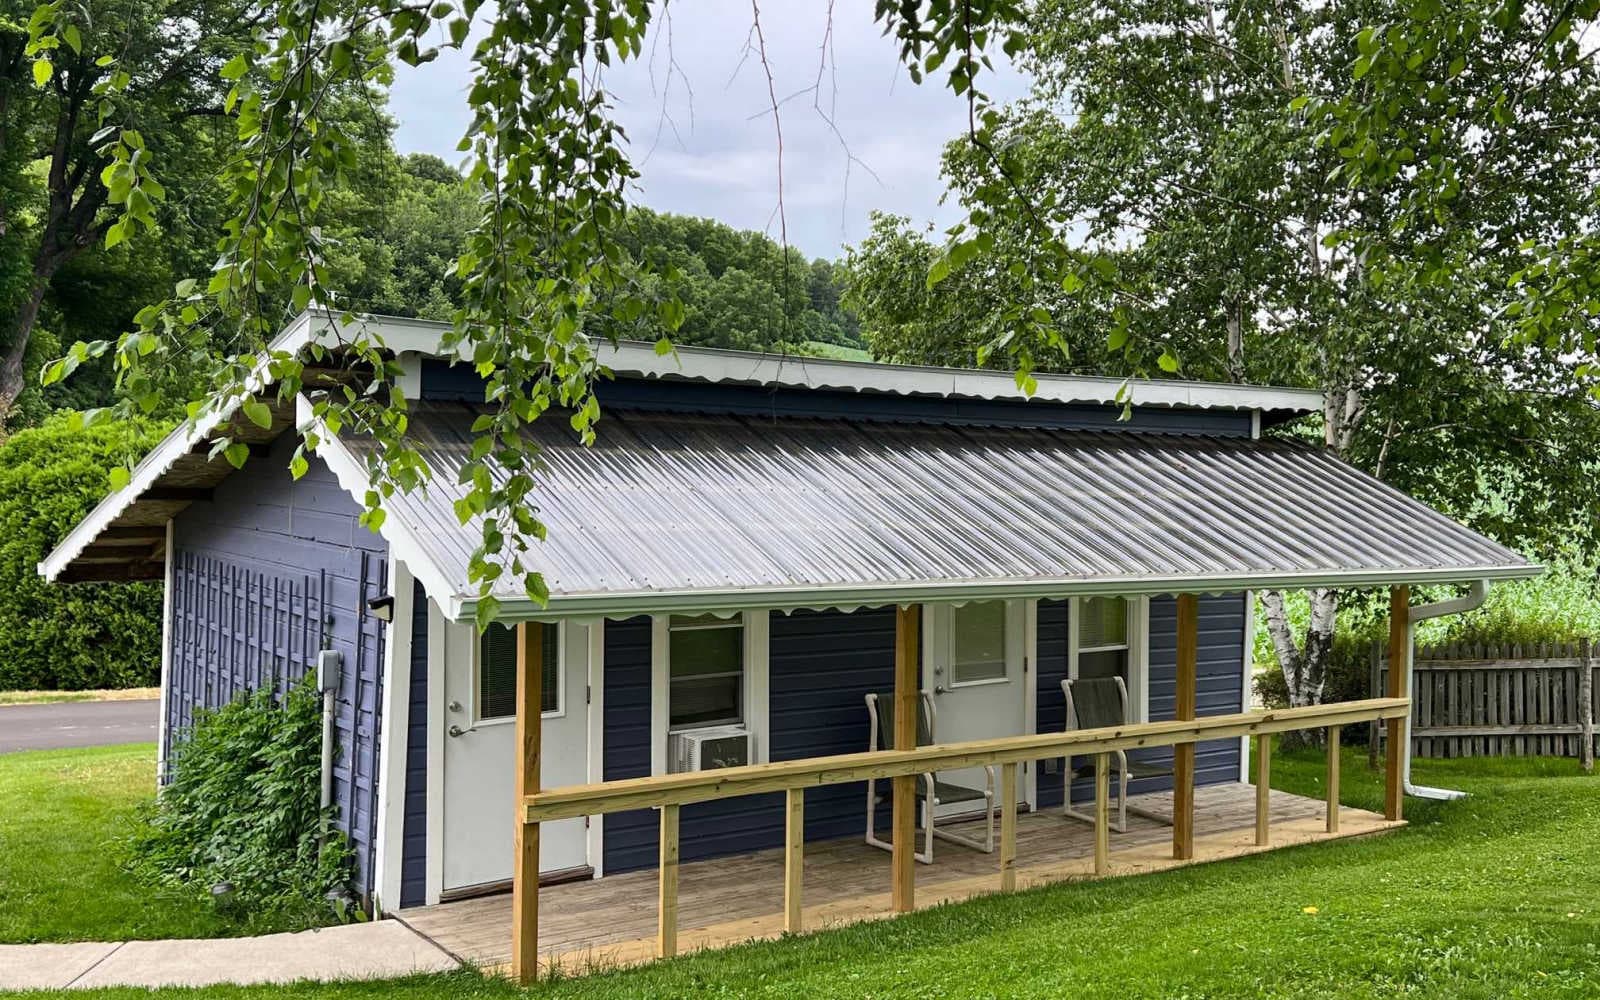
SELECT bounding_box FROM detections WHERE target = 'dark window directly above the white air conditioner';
[667,614,744,730]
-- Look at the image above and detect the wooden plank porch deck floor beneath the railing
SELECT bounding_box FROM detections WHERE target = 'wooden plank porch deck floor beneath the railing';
[398,784,1403,971]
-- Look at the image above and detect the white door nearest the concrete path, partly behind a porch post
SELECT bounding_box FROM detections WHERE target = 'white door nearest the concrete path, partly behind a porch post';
[442,622,589,893]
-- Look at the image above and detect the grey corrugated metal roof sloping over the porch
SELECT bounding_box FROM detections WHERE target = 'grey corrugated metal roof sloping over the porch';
[328,403,1539,616]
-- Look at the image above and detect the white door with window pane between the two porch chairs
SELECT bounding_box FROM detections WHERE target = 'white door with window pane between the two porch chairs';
[923,600,1029,816]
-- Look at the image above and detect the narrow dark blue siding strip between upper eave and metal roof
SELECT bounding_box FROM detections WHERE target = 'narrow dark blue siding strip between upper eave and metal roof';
[422,358,1251,437]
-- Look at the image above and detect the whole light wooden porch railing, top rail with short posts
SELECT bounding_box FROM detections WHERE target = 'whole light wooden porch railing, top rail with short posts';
[522,698,1411,957]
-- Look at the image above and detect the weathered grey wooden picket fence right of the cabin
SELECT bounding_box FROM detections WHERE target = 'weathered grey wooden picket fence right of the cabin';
[1371,638,1600,768]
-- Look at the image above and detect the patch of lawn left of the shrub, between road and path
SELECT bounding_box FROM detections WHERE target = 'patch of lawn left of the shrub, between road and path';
[0,742,291,944]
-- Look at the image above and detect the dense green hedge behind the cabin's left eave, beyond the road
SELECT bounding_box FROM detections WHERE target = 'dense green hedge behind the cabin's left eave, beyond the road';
[0,414,162,691]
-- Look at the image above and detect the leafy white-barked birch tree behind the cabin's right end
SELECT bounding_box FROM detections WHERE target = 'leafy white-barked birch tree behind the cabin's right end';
[853,0,1597,716]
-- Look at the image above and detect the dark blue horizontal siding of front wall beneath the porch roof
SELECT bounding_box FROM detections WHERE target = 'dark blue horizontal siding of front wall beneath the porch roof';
[605,595,1245,874]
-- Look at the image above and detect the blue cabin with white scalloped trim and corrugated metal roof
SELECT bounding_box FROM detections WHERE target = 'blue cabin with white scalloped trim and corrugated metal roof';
[40,315,1538,934]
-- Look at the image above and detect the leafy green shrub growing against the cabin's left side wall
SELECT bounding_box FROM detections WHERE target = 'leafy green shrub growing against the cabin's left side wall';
[128,677,352,926]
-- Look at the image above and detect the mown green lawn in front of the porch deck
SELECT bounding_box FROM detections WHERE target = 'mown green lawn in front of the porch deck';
[15,736,1600,1000]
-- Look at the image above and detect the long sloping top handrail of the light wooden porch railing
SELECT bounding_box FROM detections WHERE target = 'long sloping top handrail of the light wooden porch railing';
[523,698,1411,822]
